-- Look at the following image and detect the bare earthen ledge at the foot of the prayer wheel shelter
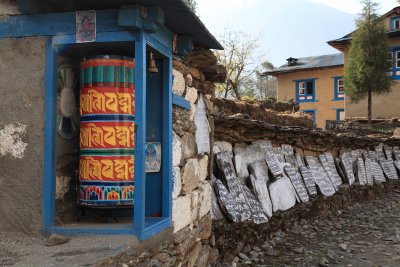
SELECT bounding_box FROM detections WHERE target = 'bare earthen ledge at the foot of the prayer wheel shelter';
[0,232,138,266]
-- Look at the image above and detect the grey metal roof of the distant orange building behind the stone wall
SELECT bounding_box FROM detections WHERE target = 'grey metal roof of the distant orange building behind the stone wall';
[265,53,344,74]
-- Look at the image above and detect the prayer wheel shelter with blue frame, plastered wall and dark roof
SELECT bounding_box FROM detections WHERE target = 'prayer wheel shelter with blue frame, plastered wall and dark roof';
[0,0,222,240]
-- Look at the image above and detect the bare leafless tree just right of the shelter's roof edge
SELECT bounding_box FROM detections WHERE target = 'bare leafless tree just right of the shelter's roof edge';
[215,30,262,99]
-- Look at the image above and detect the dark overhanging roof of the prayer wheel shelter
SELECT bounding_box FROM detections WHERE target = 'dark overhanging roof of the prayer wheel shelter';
[19,0,223,50]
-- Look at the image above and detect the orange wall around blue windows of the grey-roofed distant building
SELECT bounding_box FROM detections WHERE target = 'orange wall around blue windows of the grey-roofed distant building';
[275,67,345,129]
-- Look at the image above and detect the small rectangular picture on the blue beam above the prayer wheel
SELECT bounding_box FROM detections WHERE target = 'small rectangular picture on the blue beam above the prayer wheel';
[76,10,96,43]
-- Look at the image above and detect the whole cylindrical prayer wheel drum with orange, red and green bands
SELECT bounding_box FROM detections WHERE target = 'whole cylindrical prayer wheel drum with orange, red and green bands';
[79,56,135,208]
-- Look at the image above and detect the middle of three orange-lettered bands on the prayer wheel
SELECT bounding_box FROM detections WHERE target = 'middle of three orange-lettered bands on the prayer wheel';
[80,121,135,149]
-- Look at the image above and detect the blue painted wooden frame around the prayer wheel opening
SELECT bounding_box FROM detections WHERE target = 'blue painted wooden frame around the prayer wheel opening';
[0,10,172,240]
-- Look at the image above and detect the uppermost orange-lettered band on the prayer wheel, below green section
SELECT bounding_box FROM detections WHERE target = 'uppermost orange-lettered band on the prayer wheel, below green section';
[80,87,135,115]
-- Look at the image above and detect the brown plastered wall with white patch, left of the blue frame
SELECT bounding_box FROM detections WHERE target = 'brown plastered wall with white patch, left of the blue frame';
[0,38,45,233]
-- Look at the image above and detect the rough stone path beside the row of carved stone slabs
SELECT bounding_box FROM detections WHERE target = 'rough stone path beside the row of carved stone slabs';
[233,191,400,267]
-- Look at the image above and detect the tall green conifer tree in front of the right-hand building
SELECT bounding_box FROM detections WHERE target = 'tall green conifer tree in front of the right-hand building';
[344,0,393,127]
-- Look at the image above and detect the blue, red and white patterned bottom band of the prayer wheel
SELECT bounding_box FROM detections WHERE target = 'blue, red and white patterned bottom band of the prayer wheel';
[79,184,134,206]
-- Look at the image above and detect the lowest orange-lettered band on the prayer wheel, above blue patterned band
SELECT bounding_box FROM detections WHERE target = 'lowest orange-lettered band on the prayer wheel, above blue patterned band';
[79,155,135,182]
